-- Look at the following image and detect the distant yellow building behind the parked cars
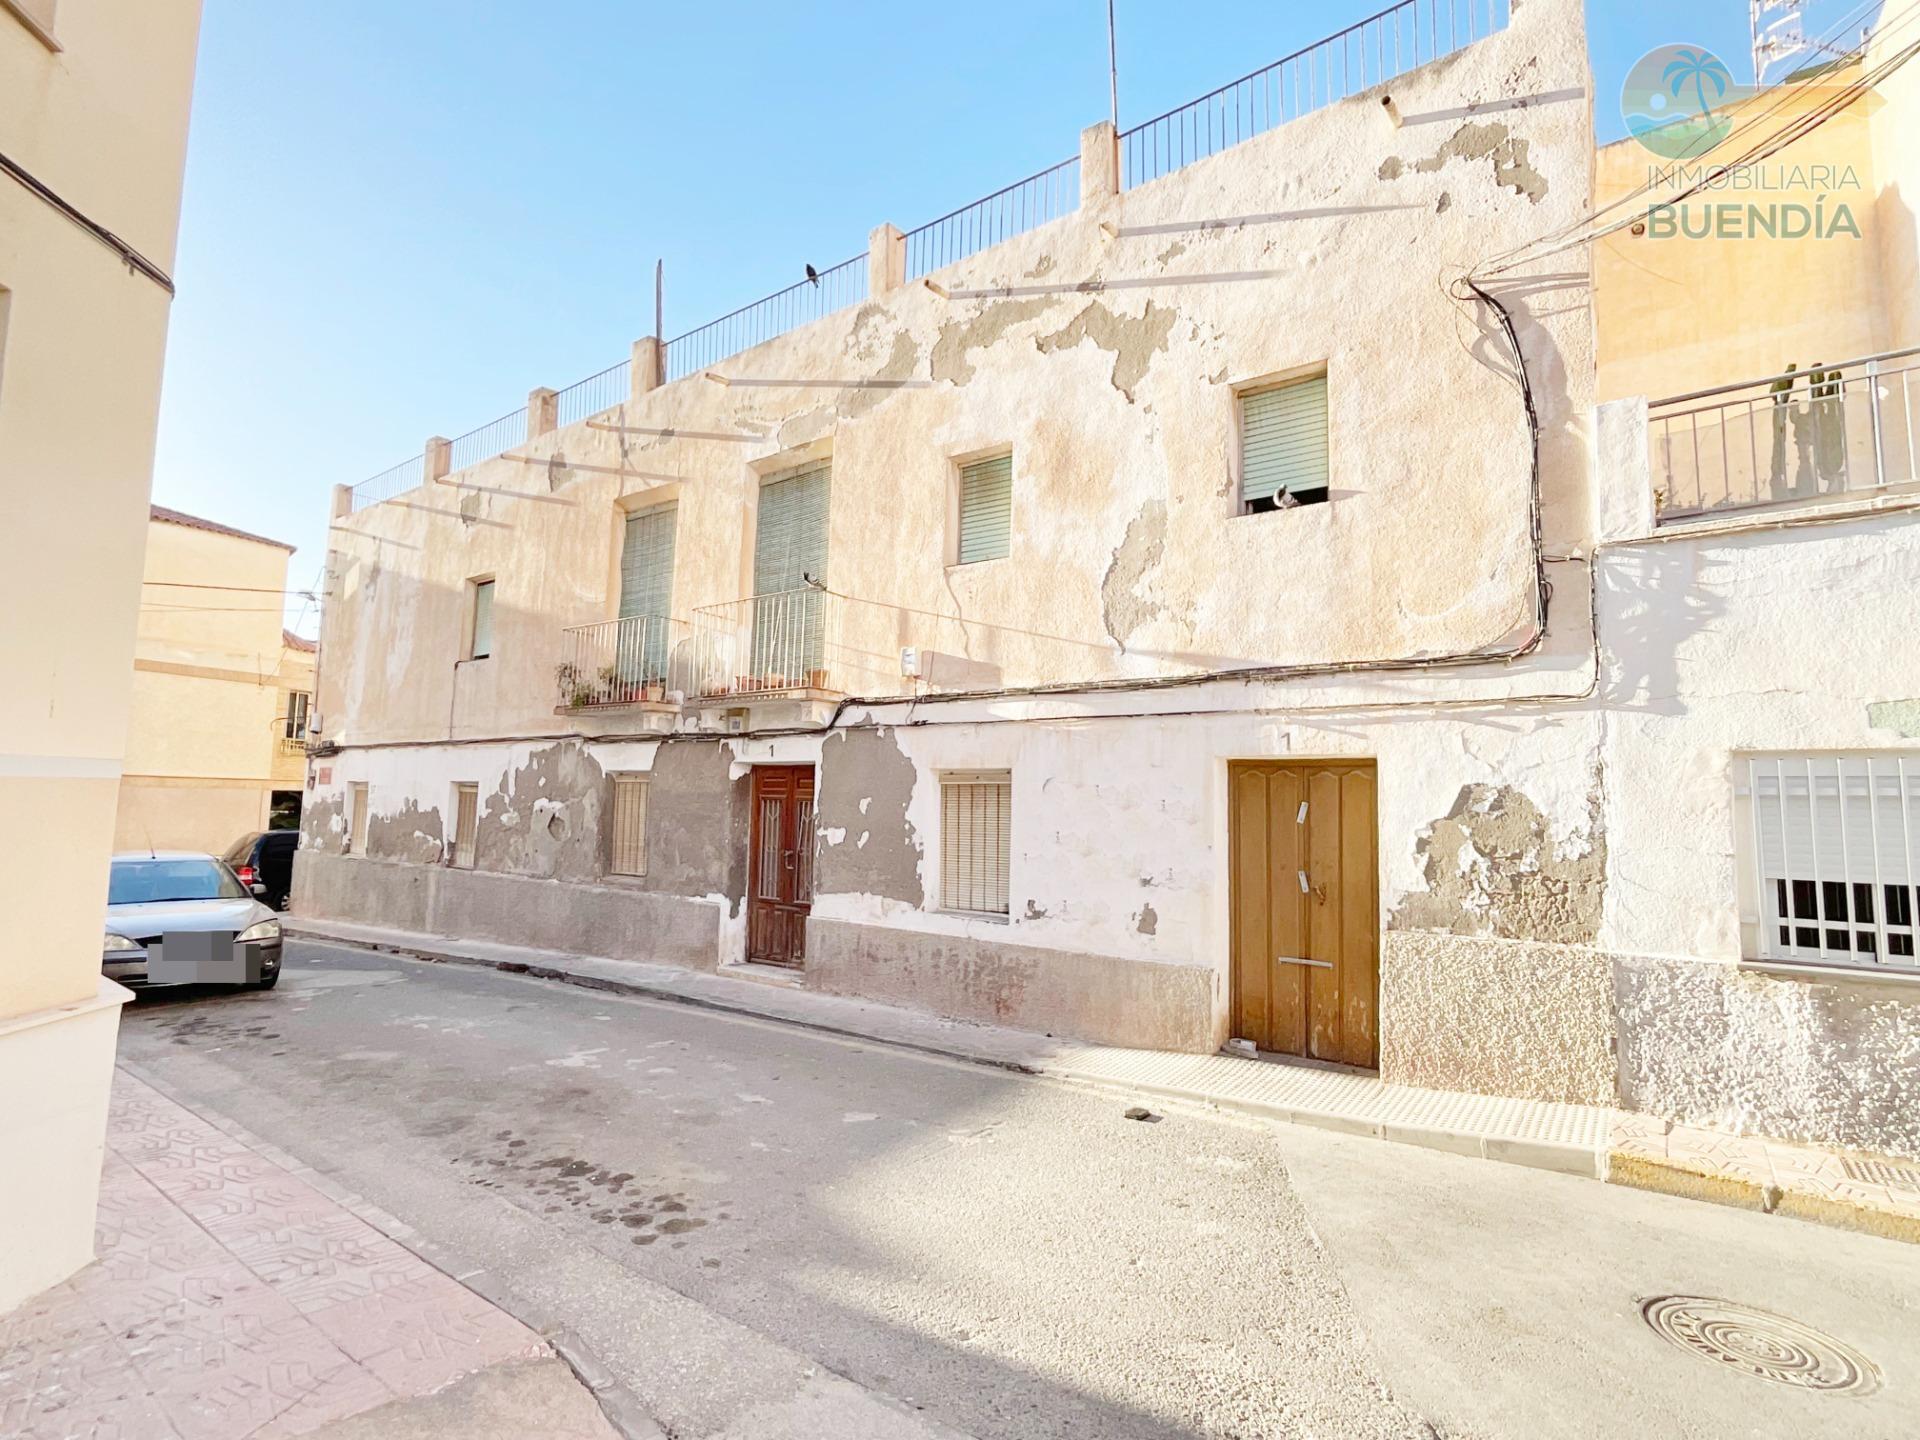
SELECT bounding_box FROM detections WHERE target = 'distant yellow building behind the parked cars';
[113,505,313,854]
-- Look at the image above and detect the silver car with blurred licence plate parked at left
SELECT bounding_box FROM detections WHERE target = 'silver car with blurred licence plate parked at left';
[100,851,280,991]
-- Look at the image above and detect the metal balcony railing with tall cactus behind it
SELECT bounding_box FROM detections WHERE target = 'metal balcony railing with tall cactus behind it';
[1647,349,1920,522]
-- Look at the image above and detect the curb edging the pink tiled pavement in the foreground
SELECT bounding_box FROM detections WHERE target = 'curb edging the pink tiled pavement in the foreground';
[113,1058,666,1440]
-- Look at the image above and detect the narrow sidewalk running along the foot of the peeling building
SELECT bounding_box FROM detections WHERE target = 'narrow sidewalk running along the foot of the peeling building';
[286,916,1920,1242]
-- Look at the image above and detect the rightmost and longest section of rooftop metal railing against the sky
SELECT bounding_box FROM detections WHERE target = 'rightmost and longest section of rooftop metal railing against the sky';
[1119,0,1511,190]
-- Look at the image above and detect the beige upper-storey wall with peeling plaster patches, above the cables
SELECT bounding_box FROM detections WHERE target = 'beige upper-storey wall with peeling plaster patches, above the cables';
[321,0,1592,745]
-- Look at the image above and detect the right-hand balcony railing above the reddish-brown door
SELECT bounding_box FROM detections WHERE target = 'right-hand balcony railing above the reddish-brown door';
[676,589,845,701]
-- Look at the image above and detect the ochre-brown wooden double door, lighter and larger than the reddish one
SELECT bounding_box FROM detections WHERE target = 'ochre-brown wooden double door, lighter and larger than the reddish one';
[1227,762,1380,1068]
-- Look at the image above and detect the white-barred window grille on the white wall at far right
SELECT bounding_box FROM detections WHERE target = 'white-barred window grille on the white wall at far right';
[1743,755,1920,970]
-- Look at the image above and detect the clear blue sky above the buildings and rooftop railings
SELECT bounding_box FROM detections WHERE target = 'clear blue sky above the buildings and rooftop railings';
[154,0,1853,634]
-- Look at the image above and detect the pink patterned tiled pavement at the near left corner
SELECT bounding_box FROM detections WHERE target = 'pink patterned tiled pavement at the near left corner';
[0,1071,605,1440]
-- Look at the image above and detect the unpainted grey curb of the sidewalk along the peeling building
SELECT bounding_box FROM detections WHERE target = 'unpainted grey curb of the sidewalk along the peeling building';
[282,922,1607,1181]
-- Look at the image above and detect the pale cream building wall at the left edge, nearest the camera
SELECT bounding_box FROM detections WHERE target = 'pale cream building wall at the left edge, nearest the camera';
[0,0,200,1313]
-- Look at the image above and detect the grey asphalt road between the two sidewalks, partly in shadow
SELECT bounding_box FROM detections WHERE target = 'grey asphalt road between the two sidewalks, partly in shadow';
[121,943,1920,1440]
